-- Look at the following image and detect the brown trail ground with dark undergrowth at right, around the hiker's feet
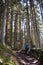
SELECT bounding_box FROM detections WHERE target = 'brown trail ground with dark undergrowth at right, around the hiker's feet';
[16,49,43,65]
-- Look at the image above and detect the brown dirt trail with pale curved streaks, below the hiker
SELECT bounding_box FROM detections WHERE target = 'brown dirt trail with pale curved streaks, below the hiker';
[16,53,39,65]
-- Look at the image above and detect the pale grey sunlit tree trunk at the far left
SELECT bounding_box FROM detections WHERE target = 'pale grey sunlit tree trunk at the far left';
[1,2,7,45]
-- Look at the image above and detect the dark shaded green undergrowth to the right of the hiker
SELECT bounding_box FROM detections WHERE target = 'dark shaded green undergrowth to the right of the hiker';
[30,49,43,59]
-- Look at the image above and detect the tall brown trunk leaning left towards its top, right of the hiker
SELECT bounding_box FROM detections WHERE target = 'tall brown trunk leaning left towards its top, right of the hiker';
[30,0,40,47]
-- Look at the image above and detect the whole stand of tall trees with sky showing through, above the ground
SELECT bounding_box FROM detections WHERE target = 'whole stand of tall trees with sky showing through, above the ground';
[0,0,43,49]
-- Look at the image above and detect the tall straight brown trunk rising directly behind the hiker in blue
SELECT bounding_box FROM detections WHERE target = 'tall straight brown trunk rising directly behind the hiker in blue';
[26,0,32,46]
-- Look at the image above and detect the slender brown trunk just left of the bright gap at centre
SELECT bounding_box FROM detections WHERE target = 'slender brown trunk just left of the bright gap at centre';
[17,11,23,50]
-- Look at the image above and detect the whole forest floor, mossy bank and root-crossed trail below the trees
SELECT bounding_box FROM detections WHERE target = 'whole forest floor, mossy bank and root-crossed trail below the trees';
[0,45,43,65]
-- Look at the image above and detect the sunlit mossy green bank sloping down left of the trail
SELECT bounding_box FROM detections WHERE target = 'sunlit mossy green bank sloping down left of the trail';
[0,45,18,65]
